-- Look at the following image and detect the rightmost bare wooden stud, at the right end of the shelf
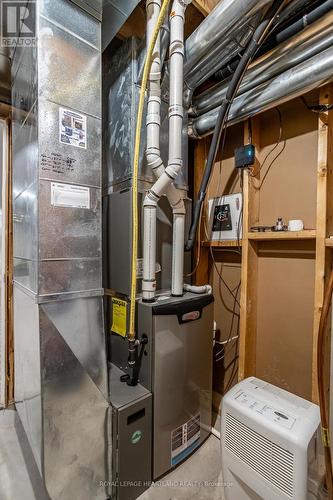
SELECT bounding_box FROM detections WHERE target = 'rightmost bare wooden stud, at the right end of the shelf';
[312,84,333,403]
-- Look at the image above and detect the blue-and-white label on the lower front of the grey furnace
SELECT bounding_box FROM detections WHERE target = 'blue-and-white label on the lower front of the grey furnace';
[171,414,200,466]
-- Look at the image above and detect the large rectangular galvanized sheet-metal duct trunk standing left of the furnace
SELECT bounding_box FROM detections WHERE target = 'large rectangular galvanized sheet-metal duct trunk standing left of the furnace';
[12,0,108,500]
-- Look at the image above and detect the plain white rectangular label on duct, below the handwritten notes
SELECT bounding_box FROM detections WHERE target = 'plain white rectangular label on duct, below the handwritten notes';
[51,182,90,208]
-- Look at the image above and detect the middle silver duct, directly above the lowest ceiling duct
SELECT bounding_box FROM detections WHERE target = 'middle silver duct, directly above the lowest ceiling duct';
[190,13,333,116]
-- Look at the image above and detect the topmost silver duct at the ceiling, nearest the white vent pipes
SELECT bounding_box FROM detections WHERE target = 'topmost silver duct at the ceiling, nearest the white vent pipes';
[184,0,271,75]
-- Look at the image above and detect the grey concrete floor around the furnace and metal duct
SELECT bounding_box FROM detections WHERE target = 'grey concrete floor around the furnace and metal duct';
[0,410,224,500]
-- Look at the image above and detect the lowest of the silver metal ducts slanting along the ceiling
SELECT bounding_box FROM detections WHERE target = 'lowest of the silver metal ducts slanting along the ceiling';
[189,47,333,138]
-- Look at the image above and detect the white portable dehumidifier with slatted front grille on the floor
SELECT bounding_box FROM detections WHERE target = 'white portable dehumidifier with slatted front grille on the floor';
[221,377,323,500]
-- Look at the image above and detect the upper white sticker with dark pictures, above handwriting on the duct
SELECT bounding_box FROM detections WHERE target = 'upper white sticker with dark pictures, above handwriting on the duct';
[59,108,87,149]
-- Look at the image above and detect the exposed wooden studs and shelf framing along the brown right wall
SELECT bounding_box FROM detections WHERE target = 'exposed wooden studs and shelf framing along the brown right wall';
[195,84,333,403]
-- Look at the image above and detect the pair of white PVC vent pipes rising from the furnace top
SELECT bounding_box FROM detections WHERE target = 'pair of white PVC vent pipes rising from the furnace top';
[142,0,189,301]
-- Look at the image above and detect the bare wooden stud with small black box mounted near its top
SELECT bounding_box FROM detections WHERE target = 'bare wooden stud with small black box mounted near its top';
[238,118,260,380]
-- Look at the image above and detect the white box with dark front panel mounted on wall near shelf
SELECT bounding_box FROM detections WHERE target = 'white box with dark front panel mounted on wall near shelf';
[208,193,243,241]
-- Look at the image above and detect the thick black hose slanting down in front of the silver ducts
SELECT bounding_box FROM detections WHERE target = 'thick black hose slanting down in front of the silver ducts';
[185,0,286,251]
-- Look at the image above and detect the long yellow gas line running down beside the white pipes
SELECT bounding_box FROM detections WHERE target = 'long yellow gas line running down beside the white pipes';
[128,0,170,341]
